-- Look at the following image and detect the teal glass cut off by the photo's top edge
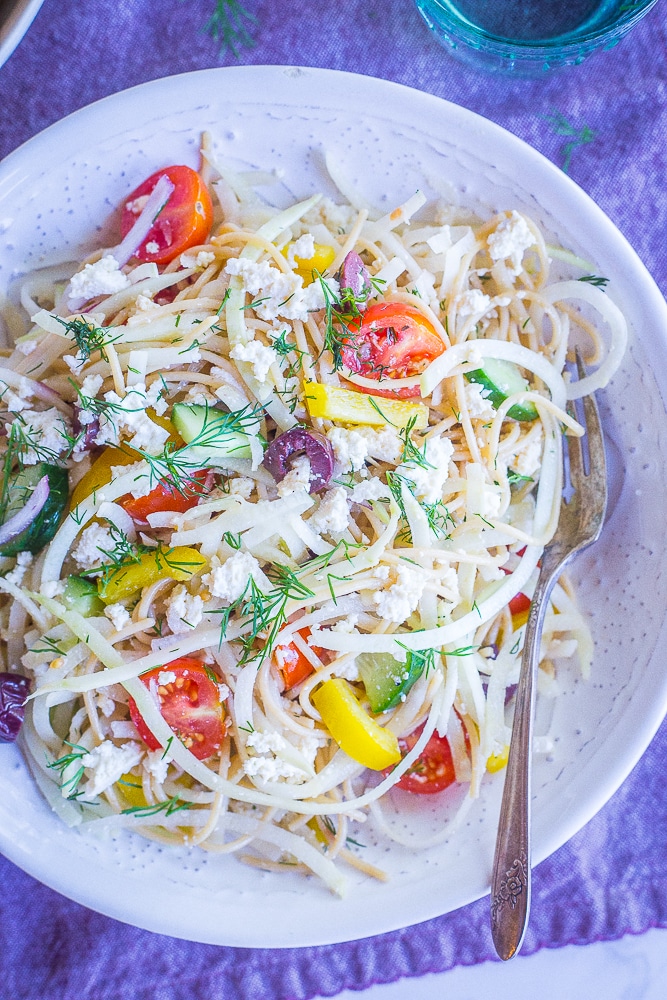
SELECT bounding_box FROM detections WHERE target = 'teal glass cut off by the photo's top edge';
[417,0,658,76]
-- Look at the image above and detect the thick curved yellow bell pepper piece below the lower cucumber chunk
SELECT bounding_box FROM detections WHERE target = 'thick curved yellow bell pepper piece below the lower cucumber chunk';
[312,677,401,771]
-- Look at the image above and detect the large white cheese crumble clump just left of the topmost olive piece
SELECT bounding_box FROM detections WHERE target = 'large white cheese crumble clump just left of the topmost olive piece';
[225,257,339,323]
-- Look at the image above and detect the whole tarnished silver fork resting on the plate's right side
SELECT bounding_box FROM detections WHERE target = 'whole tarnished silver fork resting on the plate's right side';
[491,351,607,960]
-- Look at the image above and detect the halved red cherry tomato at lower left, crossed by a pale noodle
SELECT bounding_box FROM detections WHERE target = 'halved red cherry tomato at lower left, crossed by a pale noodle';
[128,656,225,760]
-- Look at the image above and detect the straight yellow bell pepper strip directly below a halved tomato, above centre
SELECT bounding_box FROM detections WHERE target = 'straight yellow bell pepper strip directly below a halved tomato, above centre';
[305,382,428,431]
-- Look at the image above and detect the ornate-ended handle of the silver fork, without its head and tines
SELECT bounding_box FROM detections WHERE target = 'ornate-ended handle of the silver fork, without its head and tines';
[491,550,562,961]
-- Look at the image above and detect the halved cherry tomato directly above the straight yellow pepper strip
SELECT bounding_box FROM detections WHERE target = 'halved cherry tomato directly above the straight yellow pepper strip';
[341,302,445,399]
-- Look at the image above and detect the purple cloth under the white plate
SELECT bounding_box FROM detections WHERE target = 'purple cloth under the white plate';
[0,0,667,1000]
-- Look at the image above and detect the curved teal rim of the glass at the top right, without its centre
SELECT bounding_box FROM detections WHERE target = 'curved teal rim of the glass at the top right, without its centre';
[416,0,658,65]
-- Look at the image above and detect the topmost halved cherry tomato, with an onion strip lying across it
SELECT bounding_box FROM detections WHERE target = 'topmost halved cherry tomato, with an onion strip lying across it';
[120,166,213,264]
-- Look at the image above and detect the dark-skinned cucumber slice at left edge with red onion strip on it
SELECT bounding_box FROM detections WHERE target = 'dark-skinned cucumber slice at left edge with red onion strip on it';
[0,462,69,556]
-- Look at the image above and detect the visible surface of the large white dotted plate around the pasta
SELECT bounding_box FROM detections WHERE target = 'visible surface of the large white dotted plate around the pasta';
[0,67,667,947]
